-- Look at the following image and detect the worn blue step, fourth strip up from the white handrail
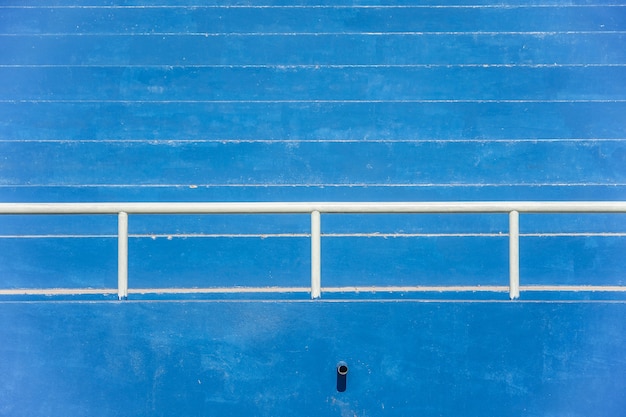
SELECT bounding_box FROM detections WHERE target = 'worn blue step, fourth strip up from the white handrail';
[0,66,626,102]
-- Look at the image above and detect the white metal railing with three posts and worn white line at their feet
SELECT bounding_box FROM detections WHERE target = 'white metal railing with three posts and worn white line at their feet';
[0,201,626,300]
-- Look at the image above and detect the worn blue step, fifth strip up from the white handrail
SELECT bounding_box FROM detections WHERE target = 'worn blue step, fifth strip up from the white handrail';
[0,31,626,66]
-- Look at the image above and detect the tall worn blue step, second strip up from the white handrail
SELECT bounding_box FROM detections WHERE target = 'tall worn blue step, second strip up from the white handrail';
[0,140,626,187]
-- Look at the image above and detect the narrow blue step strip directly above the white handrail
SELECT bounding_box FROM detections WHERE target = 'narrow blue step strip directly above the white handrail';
[0,184,626,203]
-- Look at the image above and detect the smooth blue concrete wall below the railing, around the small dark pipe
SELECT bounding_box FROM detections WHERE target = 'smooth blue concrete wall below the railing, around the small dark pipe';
[0,301,626,416]
